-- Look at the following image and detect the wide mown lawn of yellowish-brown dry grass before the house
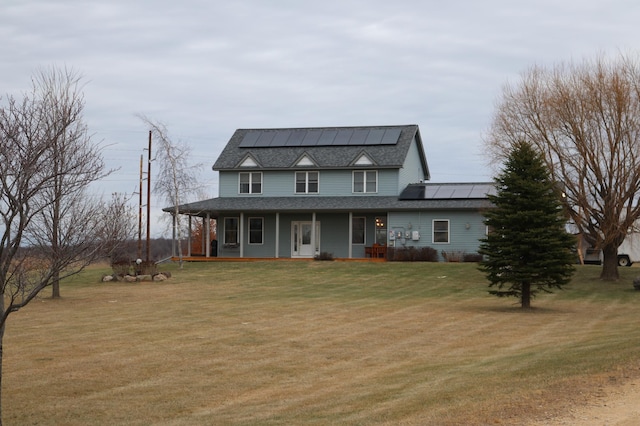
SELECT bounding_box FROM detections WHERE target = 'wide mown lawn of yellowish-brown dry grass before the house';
[3,262,640,425]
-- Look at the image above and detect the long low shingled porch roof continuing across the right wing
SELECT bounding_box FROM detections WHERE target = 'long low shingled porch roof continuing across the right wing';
[163,196,492,218]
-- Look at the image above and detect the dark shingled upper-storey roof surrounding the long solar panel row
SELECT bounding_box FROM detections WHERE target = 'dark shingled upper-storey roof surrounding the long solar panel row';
[213,124,429,180]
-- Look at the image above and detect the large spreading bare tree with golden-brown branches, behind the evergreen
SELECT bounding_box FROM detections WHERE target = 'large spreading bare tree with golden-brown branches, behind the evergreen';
[486,56,640,280]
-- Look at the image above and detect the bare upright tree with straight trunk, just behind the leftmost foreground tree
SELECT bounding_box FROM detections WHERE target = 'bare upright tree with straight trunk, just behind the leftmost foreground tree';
[22,68,111,298]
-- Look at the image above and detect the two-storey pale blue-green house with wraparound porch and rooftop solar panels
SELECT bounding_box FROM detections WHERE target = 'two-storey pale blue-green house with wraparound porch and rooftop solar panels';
[164,125,493,258]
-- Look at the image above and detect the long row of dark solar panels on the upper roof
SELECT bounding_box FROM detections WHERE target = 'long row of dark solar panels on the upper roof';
[240,127,402,148]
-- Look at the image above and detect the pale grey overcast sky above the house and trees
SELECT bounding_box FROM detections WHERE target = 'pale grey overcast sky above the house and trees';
[0,0,640,233]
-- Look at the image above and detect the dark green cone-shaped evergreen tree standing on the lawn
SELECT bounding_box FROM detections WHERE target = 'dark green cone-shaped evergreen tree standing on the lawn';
[479,142,575,308]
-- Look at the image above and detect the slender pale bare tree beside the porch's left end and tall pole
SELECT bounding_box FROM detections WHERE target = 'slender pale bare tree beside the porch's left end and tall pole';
[140,116,202,268]
